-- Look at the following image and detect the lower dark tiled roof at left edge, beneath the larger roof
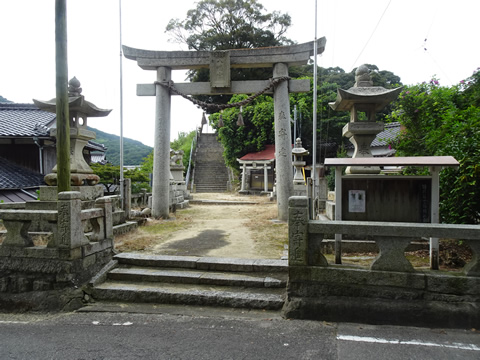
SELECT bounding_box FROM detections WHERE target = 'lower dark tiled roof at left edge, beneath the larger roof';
[0,157,45,189]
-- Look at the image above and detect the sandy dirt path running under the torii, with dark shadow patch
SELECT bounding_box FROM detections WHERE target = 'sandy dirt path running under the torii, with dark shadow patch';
[117,193,286,259]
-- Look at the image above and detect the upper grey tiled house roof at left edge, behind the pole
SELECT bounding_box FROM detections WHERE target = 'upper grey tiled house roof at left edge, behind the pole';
[0,103,56,137]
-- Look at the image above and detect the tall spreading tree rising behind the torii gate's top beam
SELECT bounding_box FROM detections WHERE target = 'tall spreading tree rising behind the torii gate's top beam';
[166,0,293,109]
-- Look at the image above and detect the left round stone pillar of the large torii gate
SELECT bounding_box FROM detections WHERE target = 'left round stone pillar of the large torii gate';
[152,67,172,219]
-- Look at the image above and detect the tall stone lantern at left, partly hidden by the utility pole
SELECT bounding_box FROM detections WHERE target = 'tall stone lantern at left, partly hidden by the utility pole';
[33,77,112,186]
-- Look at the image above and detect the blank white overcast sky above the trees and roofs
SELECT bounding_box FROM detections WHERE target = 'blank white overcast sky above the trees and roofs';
[0,0,480,146]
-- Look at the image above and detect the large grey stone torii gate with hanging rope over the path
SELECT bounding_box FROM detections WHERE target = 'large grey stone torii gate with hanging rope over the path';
[123,37,326,220]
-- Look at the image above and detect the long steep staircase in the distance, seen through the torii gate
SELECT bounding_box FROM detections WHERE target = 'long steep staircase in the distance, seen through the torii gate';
[194,134,229,192]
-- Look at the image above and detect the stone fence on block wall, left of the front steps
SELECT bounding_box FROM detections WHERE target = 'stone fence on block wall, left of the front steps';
[0,191,113,309]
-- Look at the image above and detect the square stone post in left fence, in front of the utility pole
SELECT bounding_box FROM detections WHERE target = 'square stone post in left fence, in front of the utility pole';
[54,191,89,249]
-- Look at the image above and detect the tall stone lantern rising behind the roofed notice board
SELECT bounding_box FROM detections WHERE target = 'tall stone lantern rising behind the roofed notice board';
[329,65,402,174]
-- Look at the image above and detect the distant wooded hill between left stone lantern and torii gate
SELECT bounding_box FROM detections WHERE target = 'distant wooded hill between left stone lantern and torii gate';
[89,127,153,165]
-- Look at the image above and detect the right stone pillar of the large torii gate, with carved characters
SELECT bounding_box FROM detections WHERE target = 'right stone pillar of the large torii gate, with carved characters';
[273,63,293,221]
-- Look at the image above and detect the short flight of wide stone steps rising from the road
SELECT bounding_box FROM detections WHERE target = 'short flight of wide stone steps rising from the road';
[89,253,287,310]
